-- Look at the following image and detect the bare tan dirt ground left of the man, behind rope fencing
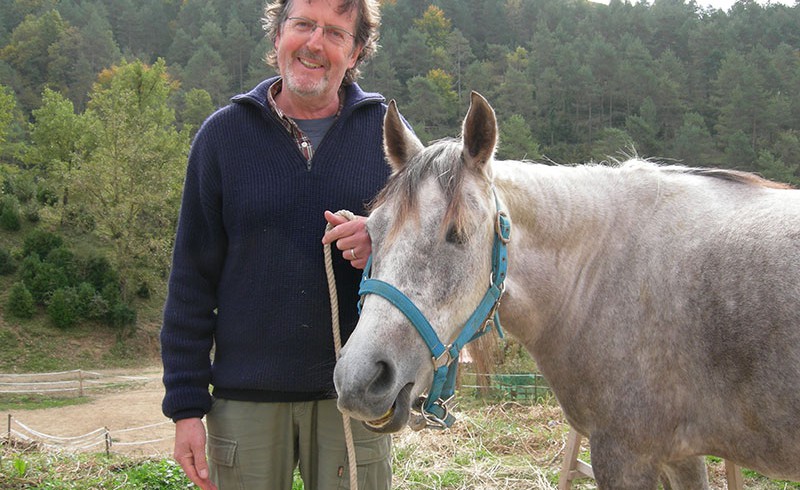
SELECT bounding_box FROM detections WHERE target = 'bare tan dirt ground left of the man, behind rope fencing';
[3,367,174,456]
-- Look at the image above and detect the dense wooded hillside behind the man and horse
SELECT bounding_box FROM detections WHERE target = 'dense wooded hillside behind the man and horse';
[0,0,800,318]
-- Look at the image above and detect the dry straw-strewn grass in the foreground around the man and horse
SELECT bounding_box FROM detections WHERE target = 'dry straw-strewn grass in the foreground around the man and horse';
[0,398,800,490]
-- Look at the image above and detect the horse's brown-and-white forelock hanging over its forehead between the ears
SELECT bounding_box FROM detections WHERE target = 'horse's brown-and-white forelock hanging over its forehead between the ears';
[369,138,482,240]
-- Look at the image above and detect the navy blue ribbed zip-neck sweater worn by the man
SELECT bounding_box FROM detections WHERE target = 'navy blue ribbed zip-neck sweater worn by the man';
[161,78,389,420]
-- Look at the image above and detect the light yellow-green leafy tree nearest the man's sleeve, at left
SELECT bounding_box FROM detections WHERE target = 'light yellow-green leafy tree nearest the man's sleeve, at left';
[73,60,189,294]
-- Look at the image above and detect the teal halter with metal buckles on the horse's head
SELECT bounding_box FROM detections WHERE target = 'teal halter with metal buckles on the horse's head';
[358,188,511,429]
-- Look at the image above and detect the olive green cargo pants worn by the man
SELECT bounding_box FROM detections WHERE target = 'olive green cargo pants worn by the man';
[206,399,392,490]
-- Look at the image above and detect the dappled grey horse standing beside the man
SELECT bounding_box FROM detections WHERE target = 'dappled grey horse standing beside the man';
[334,94,800,490]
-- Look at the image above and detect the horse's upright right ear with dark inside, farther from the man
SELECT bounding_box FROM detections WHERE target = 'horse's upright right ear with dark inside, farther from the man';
[462,92,497,169]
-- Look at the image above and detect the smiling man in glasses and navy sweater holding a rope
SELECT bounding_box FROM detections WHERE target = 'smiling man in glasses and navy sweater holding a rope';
[161,0,391,490]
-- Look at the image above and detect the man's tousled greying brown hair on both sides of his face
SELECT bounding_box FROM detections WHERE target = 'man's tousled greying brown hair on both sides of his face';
[261,0,381,85]
